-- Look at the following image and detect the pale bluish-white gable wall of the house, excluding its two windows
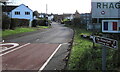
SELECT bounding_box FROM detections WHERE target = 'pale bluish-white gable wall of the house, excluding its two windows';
[10,4,33,21]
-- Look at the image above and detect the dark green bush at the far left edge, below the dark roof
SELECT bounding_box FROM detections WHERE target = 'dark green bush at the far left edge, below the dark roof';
[2,13,11,30]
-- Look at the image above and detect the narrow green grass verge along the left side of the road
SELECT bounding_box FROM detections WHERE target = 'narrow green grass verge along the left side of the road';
[0,26,49,37]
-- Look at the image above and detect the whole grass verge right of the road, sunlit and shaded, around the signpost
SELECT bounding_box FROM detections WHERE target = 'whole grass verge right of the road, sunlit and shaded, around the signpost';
[67,28,120,72]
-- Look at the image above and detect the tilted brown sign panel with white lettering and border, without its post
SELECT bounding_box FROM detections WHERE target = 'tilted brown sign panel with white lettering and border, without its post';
[93,36,118,49]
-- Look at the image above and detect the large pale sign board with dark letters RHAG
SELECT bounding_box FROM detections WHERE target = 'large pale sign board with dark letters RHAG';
[92,0,120,18]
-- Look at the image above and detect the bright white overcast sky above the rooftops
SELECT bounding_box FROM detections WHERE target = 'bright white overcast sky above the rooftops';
[9,0,91,14]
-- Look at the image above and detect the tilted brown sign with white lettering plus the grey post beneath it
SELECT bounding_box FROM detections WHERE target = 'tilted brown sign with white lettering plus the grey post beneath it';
[93,36,118,72]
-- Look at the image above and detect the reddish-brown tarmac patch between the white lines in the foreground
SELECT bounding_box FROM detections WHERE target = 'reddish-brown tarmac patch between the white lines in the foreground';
[2,43,58,70]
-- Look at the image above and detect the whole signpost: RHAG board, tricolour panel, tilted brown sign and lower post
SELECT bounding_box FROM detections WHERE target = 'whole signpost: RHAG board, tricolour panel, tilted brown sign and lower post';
[92,0,120,72]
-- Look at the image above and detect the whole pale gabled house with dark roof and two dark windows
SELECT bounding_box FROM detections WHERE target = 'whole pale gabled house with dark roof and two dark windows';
[2,4,33,27]
